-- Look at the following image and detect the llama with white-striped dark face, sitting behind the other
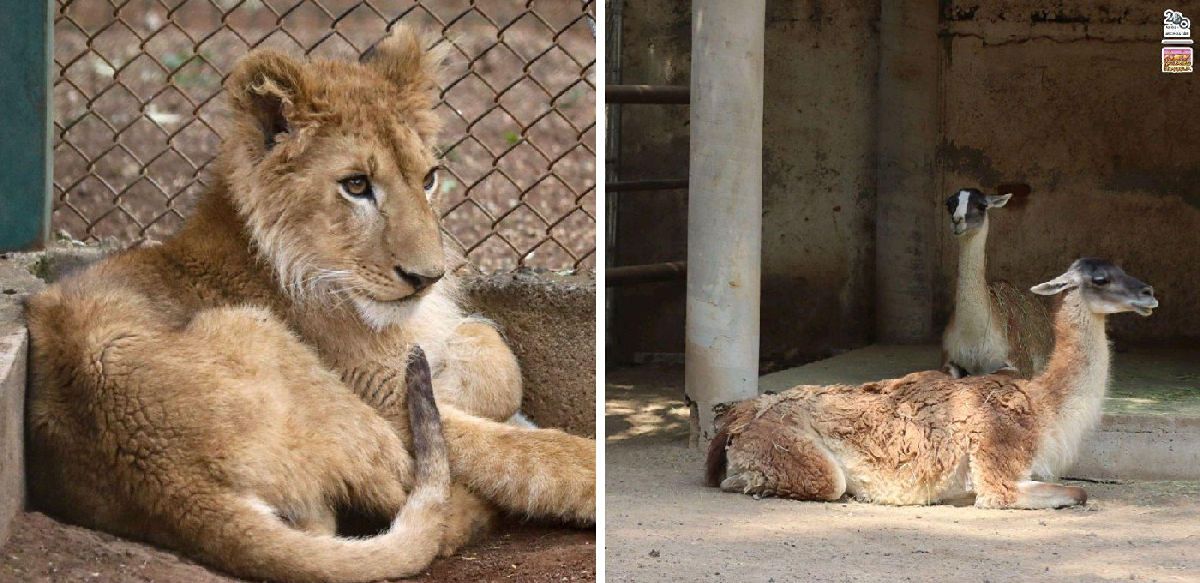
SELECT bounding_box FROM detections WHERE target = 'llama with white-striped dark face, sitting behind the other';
[942,188,1054,378]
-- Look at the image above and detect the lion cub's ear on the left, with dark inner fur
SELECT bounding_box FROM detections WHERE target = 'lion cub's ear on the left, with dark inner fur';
[226,50,308,150]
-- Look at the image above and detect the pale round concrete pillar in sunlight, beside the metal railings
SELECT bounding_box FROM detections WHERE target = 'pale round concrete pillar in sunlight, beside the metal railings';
[685,0,766,443]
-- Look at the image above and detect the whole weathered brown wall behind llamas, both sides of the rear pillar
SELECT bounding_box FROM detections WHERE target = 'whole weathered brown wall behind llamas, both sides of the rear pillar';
[610,0,1200,362]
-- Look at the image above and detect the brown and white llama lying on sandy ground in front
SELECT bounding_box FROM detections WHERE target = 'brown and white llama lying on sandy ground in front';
[707,259,1158,509]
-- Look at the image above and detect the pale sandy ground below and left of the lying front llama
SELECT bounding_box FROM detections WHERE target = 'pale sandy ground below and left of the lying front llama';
[605,368,1200,583]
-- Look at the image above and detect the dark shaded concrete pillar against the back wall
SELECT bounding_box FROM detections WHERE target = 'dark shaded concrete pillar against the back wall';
[875,0,942,343]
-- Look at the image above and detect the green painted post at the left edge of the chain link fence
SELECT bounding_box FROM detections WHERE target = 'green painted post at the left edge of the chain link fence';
[0,0,54,251]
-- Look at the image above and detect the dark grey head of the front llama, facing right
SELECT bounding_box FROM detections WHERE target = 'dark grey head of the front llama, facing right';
[1031,258,1158,315]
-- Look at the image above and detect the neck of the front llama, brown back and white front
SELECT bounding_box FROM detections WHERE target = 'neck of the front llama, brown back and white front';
[1031,289,1110,476]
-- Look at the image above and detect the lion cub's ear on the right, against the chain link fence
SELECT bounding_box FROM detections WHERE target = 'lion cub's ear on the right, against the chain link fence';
[360,24,448,94]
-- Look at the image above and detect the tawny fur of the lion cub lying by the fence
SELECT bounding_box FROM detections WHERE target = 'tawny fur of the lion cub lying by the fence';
[29,28,595,582]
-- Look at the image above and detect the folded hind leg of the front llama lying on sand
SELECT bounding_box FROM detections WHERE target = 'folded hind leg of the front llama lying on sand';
[721,417,846,500]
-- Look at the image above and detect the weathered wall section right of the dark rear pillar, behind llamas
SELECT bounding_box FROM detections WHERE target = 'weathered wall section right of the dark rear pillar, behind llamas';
[930,0,1200,342]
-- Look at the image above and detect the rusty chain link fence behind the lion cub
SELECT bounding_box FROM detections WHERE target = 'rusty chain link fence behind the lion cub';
[53,0,596,272]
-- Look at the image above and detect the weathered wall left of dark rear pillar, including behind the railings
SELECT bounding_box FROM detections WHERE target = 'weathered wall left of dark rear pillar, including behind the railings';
[610,0,878,362]
